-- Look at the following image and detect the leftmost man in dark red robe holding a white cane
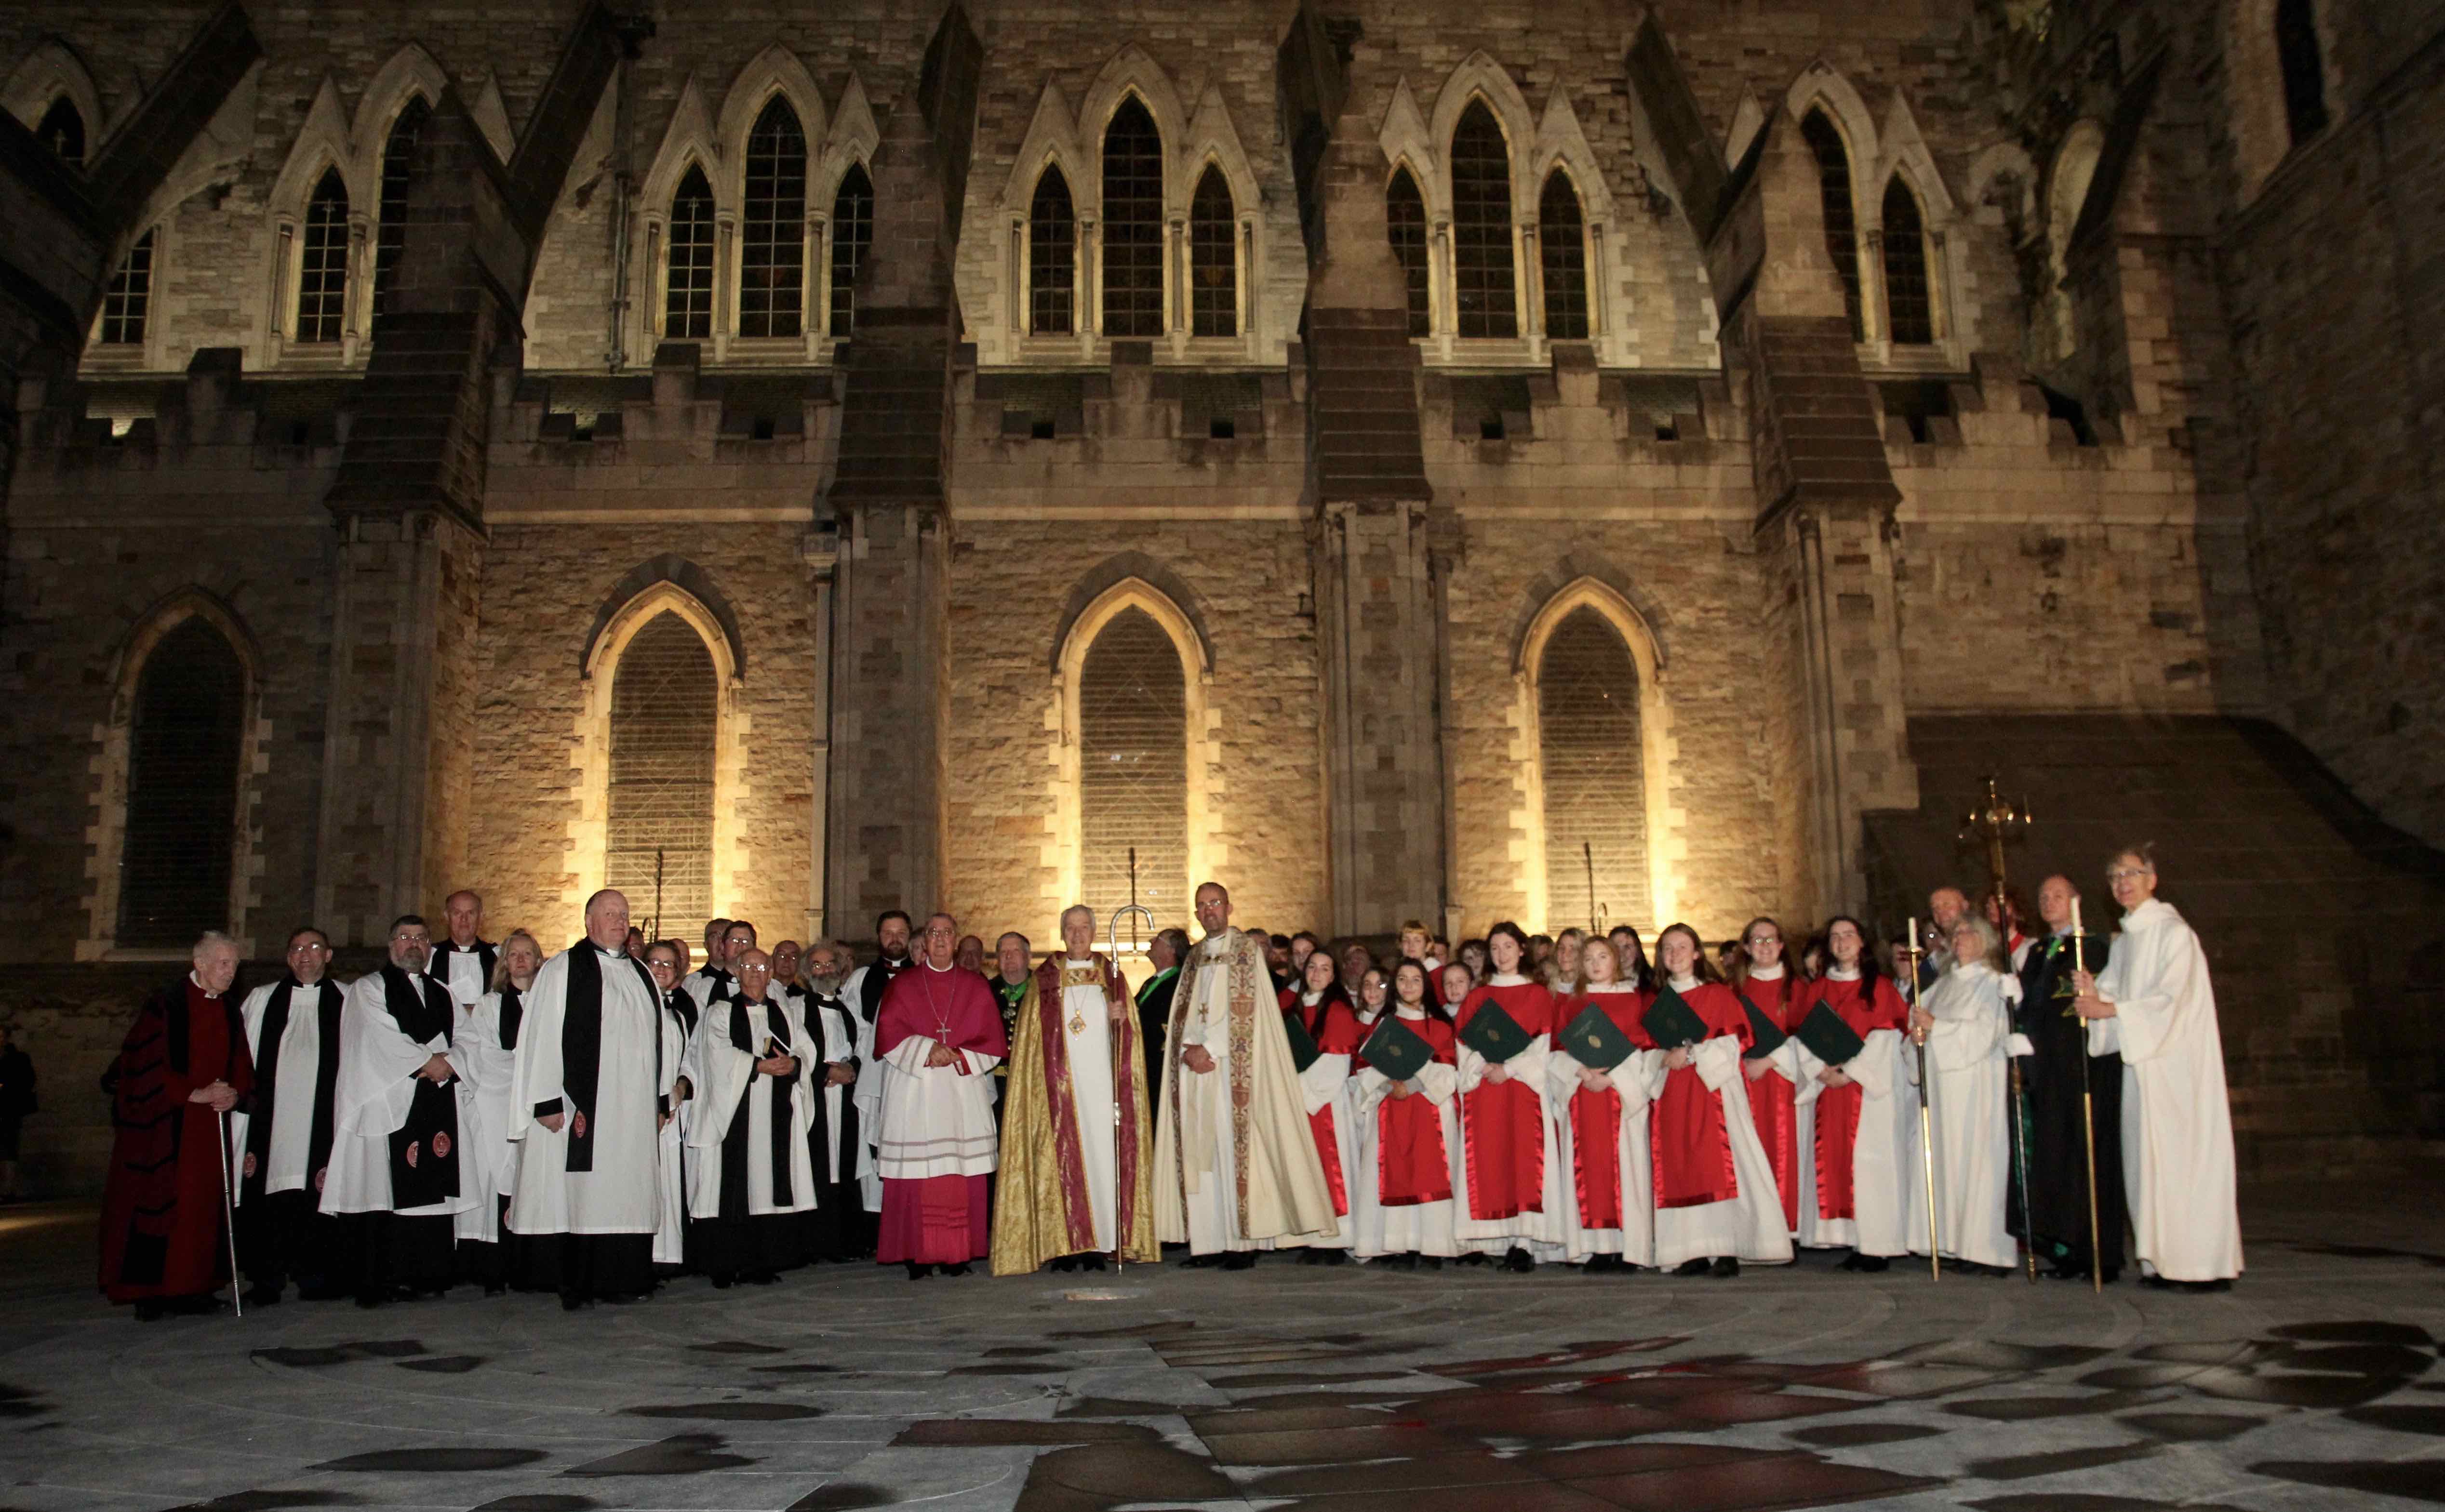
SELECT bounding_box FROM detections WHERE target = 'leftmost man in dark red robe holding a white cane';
[103,930,254,1322]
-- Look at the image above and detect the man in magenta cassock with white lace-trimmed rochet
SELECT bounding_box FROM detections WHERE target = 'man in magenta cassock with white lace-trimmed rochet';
[875,914,1010,1280]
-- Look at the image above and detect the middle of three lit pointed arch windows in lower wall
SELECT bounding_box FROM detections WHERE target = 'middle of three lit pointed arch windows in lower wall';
[1078,603,1188,918]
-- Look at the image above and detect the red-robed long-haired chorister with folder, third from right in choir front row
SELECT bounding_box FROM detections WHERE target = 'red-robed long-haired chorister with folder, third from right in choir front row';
[1641,923,1792,1275]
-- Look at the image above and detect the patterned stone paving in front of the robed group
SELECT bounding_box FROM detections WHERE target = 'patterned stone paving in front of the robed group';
[0,1190,2445,1512]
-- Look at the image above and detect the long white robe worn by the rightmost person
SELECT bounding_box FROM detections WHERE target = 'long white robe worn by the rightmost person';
[2088,899,2242,1282]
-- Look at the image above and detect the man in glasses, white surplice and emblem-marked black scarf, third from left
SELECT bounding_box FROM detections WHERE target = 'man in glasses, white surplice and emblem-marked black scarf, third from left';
[323,914,477,1307]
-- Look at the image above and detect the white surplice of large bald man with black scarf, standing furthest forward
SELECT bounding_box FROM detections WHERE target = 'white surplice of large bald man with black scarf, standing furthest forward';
[508,941,680,1233]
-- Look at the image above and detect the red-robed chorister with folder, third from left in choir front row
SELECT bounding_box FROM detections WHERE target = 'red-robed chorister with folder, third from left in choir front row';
[1452,921,1563,1273]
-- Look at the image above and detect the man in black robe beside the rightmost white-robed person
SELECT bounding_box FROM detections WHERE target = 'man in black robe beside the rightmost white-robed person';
[2005,877,2127,1280]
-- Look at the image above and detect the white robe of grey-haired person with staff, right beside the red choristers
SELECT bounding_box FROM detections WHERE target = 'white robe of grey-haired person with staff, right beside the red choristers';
[1905,962,2019,1270]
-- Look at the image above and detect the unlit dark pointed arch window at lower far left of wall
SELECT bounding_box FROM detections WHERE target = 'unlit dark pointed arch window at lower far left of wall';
[115,616,247,948]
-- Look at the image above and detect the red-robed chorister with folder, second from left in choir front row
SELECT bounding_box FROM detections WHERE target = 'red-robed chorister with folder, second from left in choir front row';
[1349,960,1467,1270]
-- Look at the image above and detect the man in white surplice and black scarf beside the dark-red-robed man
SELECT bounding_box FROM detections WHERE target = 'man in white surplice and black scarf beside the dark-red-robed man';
[230,928,357,1307]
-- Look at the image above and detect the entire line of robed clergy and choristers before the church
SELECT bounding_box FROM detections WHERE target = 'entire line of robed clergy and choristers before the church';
[100,850,2240,1316]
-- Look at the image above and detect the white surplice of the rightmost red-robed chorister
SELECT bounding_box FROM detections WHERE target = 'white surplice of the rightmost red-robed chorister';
[1792,968,1927,1260]
